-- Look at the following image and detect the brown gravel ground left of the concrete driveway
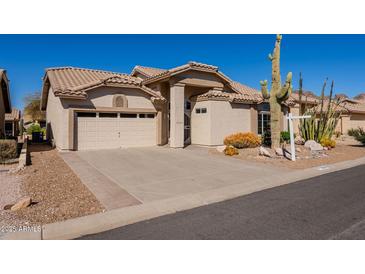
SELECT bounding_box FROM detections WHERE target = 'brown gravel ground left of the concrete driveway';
[0,145,105,230]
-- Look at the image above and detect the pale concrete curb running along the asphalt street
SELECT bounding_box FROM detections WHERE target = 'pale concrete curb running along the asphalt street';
[6,157,365,240]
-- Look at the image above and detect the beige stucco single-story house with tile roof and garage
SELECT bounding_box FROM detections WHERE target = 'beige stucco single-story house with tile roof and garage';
[41,62,296,150]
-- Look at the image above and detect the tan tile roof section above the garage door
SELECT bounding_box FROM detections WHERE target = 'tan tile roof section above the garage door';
[45,67,161,99]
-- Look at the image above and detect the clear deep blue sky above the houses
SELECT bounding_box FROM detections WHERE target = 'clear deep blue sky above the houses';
[0,34,365,108]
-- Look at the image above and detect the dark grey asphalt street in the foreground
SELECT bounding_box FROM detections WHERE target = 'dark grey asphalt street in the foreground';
[81,165,365,240]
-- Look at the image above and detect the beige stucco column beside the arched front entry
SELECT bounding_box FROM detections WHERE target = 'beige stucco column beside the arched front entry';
[170,83,185,148]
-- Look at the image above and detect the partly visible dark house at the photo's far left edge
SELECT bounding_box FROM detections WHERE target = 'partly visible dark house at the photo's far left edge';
[0,69,11,138]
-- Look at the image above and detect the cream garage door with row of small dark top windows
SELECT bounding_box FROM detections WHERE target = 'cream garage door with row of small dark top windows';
[76,112,156,150]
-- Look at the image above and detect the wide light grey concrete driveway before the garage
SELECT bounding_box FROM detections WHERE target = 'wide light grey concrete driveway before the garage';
[66,146,285,203]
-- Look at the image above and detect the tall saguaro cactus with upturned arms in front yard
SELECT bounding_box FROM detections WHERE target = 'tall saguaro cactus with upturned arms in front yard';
[260,34,292,148]
